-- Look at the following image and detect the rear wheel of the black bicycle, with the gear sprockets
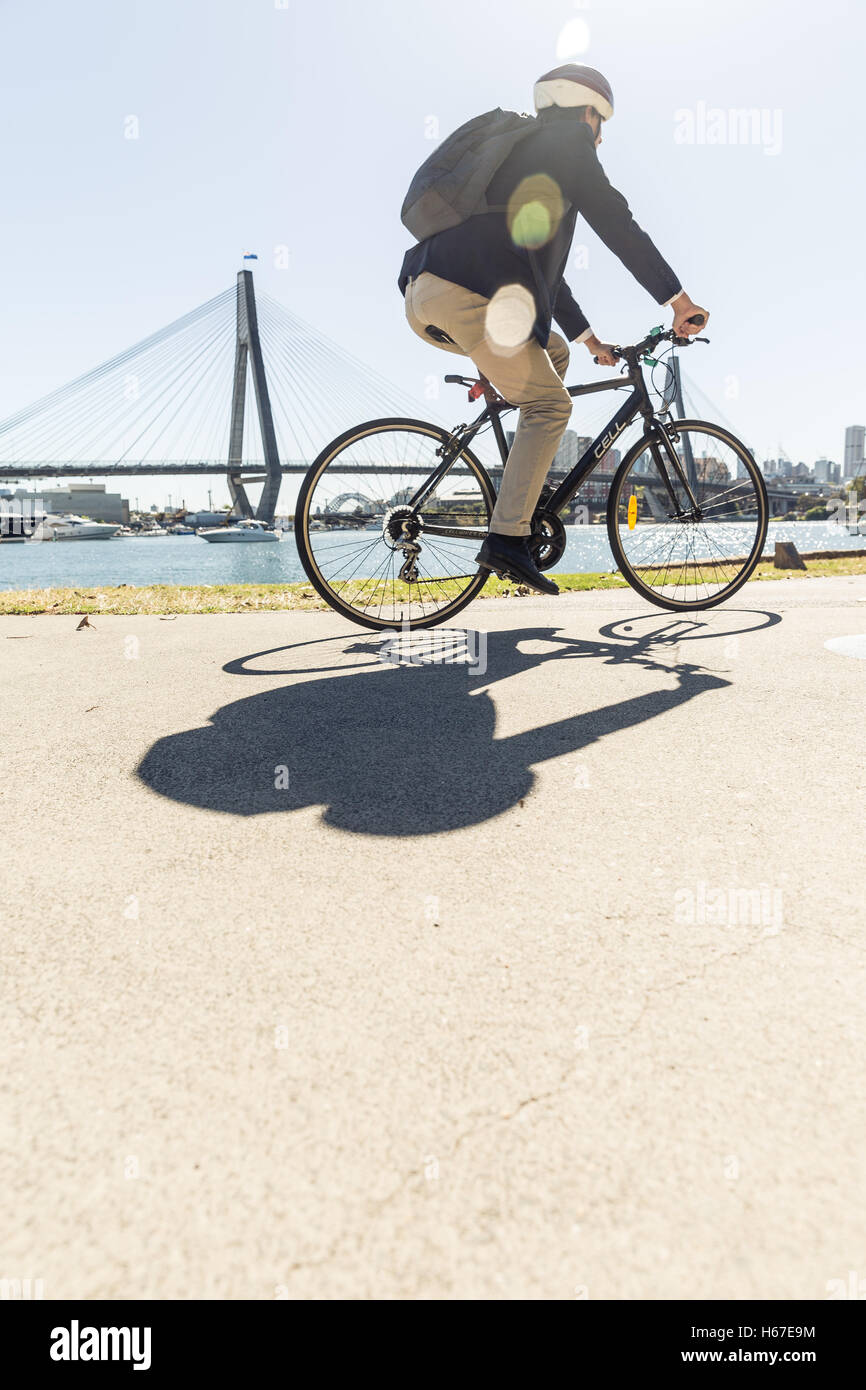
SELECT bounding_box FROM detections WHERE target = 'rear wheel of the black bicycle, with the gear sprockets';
[295,420,495,628]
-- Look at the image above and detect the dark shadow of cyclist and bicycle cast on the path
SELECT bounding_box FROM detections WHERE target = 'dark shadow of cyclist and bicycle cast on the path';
[138,614,778,837]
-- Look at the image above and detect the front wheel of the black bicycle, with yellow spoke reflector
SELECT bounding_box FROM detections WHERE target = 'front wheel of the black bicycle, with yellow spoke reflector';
[607,420,769,612]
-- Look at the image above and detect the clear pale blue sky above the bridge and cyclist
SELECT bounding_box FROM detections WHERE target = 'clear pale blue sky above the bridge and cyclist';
[0,0,866,502]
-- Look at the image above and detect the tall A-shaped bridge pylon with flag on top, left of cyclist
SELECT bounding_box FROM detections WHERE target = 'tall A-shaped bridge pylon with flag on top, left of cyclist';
[228,270,282,525]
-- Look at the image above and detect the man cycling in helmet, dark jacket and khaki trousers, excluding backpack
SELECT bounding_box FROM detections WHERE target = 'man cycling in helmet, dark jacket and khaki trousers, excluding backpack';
[399,63,709,594]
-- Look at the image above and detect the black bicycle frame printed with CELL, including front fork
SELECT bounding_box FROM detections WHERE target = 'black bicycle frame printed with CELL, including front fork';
[409,357,698,537]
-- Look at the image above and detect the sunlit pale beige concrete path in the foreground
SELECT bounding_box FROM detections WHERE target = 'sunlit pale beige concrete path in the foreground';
[0,577,866,1300]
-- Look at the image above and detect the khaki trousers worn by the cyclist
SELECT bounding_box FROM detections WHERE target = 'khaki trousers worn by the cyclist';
[406,271,571,535]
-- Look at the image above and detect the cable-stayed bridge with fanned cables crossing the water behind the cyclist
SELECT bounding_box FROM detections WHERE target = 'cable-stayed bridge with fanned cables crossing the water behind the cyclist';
[0,270,767,523]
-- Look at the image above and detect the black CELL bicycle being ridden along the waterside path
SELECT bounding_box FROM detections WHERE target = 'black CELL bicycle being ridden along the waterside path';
[295,319,769,630]
